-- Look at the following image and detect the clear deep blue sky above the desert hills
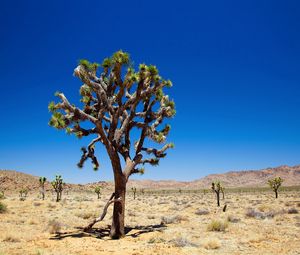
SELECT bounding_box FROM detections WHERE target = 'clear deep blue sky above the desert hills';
[0,0,300,182]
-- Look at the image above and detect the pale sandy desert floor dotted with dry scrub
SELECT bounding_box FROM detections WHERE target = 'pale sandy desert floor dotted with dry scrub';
[0,191,300,255]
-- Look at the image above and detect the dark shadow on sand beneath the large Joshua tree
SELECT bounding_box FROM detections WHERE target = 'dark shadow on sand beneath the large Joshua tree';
[49,223,167,240]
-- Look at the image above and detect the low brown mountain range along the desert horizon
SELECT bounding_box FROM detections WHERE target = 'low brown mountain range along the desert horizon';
[0,165,300,190]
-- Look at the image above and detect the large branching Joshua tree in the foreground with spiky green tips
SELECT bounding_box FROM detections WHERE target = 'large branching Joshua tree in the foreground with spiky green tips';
[49,51,175,238]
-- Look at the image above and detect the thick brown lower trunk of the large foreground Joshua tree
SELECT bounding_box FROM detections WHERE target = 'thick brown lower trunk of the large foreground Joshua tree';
[110,172,127,239]
